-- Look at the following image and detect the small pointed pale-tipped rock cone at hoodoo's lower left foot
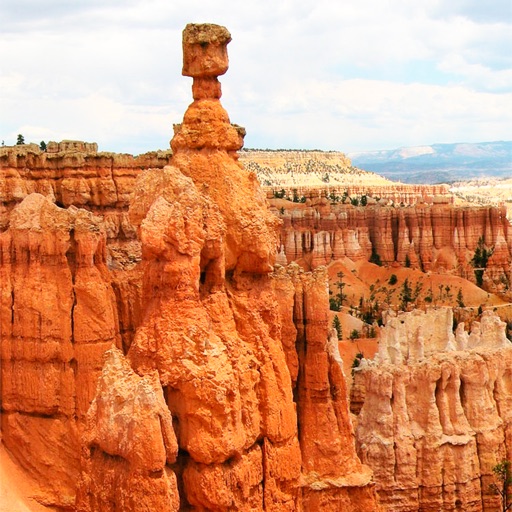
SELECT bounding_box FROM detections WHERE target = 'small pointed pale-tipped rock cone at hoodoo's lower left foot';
[77,348,179,512]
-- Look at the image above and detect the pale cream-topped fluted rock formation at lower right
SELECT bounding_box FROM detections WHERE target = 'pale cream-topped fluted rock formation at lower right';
[355,309,512,512]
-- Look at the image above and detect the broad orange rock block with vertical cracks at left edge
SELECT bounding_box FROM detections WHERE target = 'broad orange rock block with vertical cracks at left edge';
[0,194,120,506]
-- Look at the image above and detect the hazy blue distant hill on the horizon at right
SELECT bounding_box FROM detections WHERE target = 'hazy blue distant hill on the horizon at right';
[348,141,512,184]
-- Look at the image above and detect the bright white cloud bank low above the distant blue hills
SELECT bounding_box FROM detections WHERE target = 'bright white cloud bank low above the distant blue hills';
[236,80,512,151]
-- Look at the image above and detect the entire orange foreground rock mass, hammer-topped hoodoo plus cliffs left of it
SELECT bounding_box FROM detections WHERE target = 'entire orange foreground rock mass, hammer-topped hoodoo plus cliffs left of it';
[0,25,379,512]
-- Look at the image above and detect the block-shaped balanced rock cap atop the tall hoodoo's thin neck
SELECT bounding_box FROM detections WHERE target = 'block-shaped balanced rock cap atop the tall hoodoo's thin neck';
[182,23,231,78]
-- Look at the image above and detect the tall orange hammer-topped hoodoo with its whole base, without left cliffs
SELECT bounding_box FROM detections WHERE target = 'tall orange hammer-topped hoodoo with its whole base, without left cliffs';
[77,25,378,512]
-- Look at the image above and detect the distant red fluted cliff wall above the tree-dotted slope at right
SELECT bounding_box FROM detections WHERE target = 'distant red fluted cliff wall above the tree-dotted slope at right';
[274,202,512,291]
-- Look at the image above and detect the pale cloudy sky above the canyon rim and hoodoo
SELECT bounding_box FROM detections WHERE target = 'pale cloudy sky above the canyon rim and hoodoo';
[0,0,512,154]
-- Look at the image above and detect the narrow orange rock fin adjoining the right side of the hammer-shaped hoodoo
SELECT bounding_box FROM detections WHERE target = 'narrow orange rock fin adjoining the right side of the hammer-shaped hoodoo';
[289,266,376,511]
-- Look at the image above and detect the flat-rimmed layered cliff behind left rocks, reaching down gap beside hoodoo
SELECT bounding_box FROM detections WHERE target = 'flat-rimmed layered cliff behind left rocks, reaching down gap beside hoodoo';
[0,141,171,354]
